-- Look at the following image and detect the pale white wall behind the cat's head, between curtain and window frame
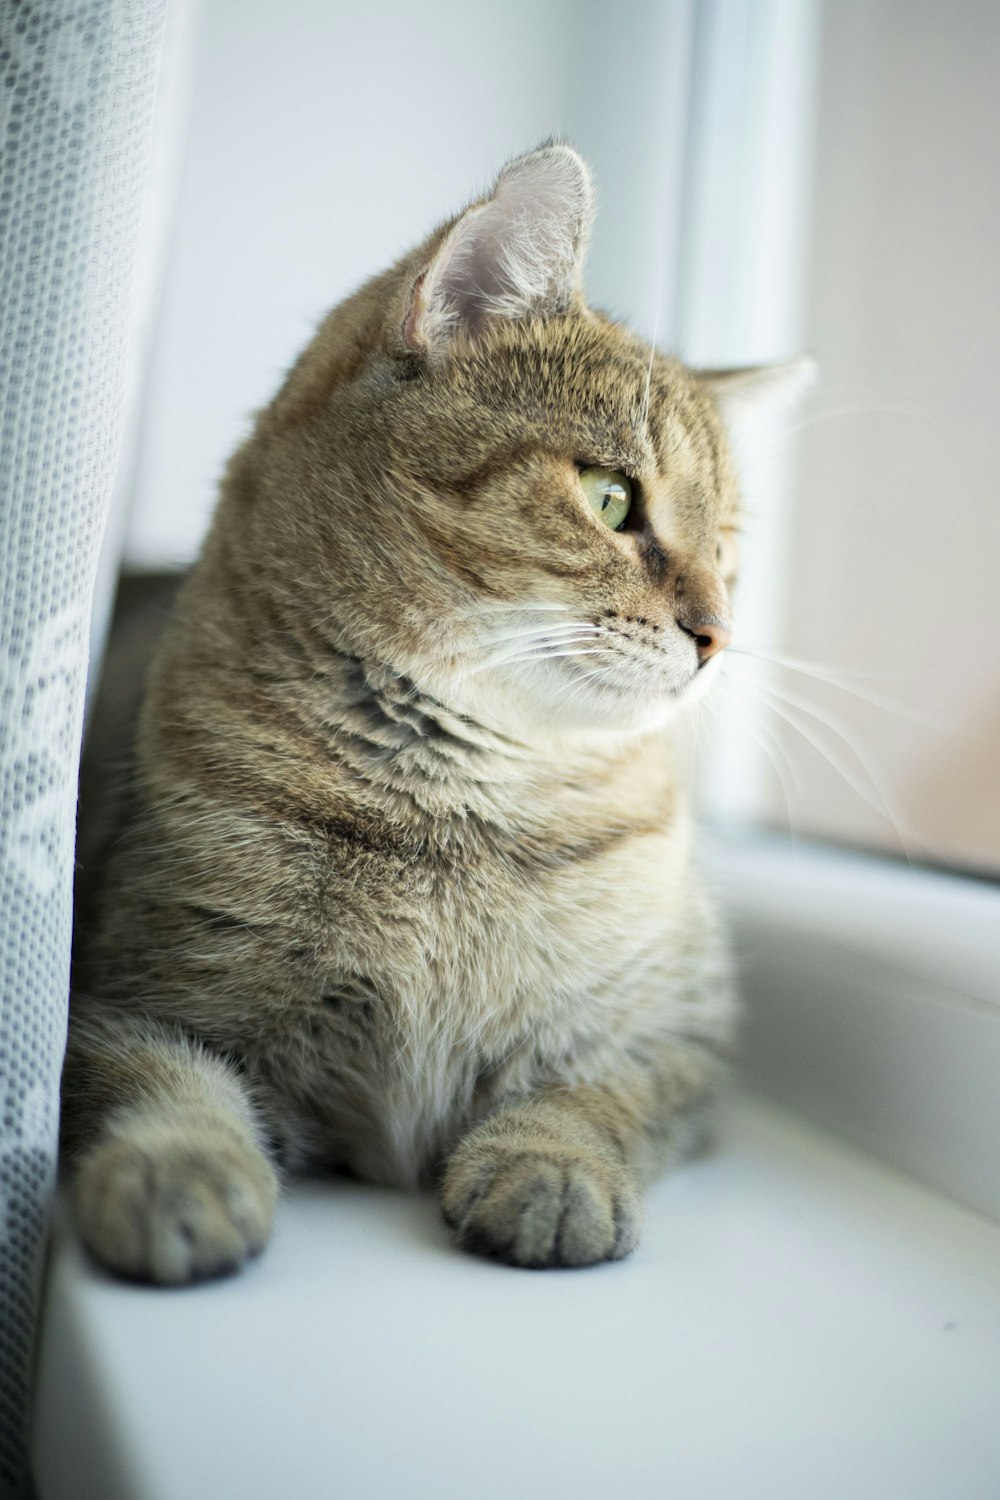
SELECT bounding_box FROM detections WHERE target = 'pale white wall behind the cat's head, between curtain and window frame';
[126,0,693,567]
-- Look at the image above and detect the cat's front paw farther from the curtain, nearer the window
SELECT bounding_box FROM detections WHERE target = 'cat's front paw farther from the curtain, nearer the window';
[441,1136,640,1268]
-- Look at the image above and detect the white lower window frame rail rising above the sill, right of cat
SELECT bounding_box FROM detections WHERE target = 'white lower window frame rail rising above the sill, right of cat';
[706,839,1000,1221]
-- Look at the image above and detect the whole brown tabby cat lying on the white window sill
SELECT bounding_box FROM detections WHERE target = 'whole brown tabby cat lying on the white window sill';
[63,143,803,1284]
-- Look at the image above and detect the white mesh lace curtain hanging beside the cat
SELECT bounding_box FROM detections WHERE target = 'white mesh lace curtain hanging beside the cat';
[0,0,166,1497]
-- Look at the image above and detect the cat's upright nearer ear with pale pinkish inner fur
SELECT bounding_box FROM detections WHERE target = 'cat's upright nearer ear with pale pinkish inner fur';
[403,144,594,354]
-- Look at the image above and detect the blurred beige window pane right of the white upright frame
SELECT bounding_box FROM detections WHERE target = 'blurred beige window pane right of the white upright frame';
[758,0,1000,870]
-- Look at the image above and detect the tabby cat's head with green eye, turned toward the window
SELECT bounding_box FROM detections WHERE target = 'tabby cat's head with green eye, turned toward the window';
[244,144,815,737]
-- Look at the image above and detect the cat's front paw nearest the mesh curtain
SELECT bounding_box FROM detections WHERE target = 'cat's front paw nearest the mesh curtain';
[73,1112,277,1286]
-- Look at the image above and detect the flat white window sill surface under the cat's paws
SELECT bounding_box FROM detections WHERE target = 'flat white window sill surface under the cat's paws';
[34,1098,1000,1500]
